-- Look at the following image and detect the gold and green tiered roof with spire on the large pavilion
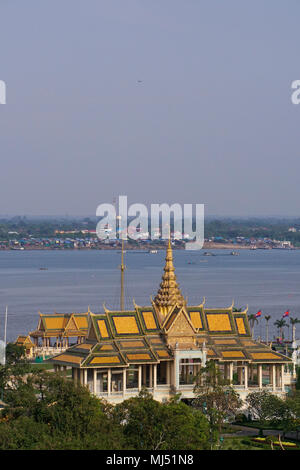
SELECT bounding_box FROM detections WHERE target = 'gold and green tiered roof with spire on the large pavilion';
[52,241,290,367]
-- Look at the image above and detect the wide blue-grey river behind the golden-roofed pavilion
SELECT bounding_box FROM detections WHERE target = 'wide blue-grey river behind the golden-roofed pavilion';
[0,250,300,341]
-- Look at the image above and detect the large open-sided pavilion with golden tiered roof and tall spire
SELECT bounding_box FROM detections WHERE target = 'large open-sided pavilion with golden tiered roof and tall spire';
[51,241,292,403]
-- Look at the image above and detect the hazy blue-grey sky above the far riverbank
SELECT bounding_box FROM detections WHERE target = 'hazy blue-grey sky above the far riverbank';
[0,0,300,215]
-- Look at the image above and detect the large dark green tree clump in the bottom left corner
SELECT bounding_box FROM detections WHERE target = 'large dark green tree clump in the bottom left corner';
[0,371,124,450]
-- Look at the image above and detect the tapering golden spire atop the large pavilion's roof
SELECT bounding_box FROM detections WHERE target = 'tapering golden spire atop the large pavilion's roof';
[154,238,185,315]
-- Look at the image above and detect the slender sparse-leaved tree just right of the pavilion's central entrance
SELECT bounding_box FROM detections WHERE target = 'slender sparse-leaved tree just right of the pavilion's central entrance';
[194,361,242,432]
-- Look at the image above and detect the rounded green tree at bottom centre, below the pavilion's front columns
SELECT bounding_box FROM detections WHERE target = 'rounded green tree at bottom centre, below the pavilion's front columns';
[114,390,209,450]
